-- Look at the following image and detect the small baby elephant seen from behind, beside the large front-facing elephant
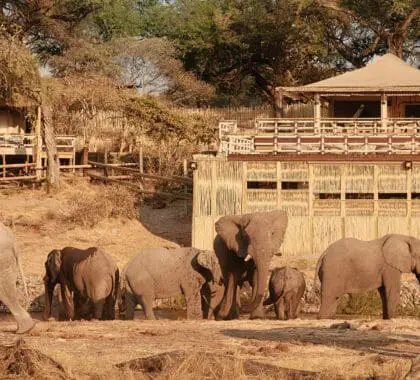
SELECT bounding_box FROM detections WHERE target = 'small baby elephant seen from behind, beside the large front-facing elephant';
[264,267,306,320]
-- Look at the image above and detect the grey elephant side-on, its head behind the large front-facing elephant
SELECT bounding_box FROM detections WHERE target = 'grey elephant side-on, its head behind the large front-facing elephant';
[120,247,222,320]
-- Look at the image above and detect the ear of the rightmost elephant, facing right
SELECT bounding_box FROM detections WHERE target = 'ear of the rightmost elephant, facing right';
[383,236,413,273]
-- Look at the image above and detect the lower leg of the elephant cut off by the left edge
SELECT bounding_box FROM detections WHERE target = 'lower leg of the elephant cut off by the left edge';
[0,275,35,334]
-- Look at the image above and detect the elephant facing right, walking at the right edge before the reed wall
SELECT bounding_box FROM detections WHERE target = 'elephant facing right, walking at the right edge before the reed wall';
[315,234,420,319]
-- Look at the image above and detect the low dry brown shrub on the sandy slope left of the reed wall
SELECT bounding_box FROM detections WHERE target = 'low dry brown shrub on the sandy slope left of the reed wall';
[61,185,138,228]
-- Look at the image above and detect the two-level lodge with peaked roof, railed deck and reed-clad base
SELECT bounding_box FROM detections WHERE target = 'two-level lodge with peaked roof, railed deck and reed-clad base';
[192,54,420,258]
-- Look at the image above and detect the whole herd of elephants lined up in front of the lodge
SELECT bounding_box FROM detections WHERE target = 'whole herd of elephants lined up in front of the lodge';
[0,210,420,333]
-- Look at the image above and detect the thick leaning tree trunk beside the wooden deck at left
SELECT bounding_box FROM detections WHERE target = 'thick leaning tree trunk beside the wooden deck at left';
[42,105,60,192]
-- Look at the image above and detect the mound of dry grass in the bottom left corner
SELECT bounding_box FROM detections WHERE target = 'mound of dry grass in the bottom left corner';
[0,340,70,380]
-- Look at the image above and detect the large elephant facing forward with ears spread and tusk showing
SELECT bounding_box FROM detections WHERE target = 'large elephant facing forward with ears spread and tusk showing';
[214,210,288,320]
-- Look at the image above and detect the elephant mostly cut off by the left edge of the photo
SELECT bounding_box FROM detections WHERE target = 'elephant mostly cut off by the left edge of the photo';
[0,223,35,334]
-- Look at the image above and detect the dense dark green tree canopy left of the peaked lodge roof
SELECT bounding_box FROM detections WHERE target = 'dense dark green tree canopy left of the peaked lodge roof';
[148,0,329,105]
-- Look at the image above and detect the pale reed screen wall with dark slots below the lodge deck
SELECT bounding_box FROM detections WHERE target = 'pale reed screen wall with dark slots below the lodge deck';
[192,156,420,258]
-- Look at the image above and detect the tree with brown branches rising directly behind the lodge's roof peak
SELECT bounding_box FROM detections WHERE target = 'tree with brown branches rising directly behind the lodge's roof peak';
[311,0,420,67]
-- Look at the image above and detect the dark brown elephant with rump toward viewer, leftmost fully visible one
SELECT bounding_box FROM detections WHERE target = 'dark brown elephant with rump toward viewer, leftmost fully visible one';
[44,247,120,320]
